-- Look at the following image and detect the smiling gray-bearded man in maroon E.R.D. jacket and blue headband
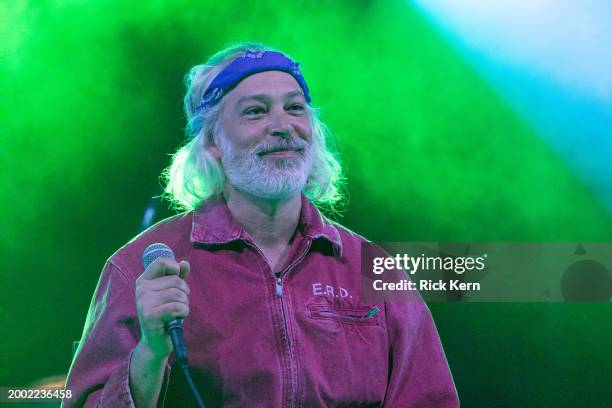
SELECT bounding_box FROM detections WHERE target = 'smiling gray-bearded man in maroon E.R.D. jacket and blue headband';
[64,44,458,407]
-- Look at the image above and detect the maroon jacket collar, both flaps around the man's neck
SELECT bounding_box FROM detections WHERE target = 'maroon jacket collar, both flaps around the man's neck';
[191,194,342,256]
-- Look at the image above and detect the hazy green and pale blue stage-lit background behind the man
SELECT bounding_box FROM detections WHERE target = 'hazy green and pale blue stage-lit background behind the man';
[0,0,612,407]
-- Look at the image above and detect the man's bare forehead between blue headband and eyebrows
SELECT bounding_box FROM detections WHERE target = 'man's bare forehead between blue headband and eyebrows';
[226,71,303,102]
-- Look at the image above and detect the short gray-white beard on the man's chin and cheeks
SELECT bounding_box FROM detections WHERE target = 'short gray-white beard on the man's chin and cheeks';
[219,136,312,200]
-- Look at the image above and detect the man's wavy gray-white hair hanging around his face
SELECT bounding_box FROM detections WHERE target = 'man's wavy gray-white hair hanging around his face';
[162,43,345,211]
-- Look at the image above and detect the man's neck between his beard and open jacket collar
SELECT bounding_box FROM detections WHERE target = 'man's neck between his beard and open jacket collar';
[223,183,302,248]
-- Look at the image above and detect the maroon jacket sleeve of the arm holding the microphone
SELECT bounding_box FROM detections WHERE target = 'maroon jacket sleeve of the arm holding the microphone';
[62,261,170,408]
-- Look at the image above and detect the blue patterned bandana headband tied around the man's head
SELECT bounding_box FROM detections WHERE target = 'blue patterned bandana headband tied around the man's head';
[196,51,310,113]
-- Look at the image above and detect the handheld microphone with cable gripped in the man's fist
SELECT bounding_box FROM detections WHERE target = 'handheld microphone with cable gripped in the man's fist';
[142,242,205,408]
